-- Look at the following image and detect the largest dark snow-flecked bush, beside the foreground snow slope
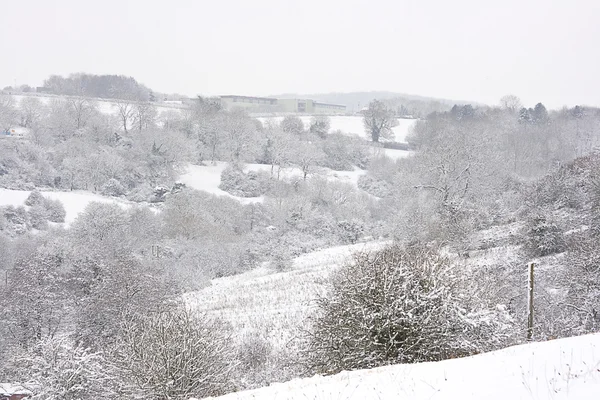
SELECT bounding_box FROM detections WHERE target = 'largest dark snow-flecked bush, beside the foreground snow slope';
[306,246,506,373]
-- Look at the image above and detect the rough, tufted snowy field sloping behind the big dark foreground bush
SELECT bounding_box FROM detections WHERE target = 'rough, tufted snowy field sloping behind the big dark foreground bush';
[185,238,385,351]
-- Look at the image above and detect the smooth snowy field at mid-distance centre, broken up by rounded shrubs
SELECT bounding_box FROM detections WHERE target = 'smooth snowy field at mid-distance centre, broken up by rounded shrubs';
[179,161,366,204]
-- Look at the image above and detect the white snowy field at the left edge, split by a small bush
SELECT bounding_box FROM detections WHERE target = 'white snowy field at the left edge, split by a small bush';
[0,188,131,226]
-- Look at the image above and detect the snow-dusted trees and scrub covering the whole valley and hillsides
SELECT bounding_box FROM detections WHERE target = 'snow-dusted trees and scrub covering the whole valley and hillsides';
[0,94,600,399]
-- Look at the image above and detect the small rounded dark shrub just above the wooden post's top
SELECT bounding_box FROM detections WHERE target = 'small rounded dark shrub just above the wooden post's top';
[523,214,565,257]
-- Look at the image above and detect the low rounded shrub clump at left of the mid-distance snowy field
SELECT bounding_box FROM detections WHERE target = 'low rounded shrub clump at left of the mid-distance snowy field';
[219,165,270,197]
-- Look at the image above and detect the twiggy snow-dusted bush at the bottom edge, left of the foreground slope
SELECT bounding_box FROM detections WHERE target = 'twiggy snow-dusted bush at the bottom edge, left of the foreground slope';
[117,309,235,400]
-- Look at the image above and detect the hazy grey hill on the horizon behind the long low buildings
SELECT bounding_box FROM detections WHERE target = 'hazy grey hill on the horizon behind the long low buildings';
[270,91,476,117]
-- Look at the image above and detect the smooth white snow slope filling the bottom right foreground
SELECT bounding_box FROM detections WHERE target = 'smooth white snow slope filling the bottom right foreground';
[204,334,600,400]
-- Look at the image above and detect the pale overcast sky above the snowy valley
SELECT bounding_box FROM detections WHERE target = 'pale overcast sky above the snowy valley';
[0,0,600,107]
